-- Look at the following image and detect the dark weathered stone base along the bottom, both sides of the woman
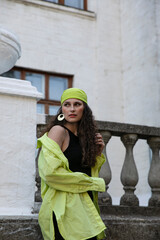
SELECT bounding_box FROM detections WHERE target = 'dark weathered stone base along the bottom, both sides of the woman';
[0,206,160,240]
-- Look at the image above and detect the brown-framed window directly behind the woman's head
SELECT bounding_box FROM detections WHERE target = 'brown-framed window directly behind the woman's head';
[2,68,73,115]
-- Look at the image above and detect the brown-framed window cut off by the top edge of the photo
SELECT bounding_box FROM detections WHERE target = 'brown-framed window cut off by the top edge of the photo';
[43,0,87,10]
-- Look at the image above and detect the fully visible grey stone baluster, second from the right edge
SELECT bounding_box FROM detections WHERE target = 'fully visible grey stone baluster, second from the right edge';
[120,134,139,206]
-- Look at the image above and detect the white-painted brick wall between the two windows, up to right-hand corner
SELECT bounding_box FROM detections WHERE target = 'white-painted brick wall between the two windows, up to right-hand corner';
[0,0,123,121]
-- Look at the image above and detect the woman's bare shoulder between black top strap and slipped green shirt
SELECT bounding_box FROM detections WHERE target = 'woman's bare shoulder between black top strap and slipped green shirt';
[48,125,66,148]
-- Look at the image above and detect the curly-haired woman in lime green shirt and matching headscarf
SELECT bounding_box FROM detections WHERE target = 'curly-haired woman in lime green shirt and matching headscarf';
[38,88,105,240]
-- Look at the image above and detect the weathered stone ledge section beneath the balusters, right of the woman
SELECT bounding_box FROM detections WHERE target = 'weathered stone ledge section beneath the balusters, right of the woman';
[100,206,160,240]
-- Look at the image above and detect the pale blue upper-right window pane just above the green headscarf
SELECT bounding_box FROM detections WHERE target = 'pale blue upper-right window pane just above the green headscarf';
[49,76,68,101]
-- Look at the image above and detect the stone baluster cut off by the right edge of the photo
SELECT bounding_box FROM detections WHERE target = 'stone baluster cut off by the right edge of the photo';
[147,137,160,207]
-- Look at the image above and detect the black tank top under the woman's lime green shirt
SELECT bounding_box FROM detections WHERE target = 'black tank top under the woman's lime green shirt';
[62,126,91,176]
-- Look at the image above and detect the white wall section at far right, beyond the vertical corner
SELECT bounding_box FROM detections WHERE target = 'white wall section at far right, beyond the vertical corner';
[121,0,160,126]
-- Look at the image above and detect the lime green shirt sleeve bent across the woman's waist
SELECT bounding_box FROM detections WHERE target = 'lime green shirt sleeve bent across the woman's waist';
[38,136,105,193]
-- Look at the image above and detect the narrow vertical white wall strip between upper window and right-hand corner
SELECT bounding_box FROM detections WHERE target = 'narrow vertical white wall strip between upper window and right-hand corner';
[89,0,123,122]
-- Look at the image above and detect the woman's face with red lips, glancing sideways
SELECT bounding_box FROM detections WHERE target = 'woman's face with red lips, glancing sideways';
[62,98,84,123]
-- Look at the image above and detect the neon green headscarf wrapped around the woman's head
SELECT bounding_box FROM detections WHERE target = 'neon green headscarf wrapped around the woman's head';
[61,88,87,104]
